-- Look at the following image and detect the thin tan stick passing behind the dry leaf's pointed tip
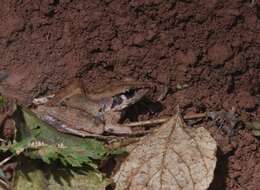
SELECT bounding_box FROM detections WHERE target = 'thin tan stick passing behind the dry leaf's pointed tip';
[125,113,207,127]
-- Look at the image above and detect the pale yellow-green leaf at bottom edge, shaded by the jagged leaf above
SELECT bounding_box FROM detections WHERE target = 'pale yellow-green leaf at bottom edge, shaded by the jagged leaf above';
[13,160,112,190]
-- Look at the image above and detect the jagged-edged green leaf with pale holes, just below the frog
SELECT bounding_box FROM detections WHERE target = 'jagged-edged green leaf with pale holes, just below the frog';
[12,108,112,168]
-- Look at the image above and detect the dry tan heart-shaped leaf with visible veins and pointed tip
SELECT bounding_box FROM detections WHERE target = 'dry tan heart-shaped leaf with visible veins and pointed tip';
[113,114,217,190]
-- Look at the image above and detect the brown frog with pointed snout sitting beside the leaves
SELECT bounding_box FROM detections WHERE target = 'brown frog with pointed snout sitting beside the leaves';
[31,79,151,137]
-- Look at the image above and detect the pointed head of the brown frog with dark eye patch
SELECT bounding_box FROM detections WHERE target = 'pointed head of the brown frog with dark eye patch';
[88,80,150,112]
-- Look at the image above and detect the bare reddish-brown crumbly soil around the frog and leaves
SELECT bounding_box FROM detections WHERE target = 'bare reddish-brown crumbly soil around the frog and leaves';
[0,0,260,190]
